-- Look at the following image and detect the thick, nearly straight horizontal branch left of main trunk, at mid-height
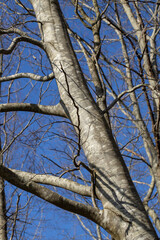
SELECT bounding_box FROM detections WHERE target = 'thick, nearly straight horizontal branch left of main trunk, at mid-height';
[0,101,67,118]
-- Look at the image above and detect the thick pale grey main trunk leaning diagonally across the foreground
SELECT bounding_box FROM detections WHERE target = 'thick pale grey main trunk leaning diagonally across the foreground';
[30,0,158,240]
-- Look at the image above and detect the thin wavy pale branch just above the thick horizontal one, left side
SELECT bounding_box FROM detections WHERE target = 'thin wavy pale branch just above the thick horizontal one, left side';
[0,72,55,82]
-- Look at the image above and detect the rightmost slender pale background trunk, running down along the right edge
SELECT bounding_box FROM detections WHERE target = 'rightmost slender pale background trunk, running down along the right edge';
[120,0,160,201]
